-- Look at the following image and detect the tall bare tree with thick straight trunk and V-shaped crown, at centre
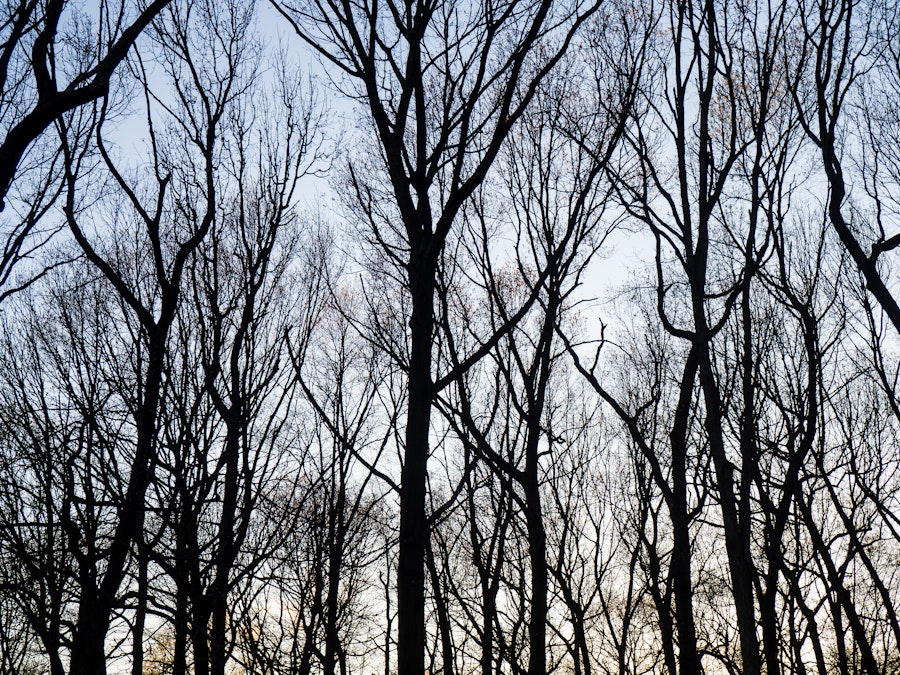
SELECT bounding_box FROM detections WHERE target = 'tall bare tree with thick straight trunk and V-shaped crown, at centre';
[276,1,612,675]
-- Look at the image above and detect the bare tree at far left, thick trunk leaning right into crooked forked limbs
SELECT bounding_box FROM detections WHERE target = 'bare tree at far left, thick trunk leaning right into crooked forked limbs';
[49,4,250,673]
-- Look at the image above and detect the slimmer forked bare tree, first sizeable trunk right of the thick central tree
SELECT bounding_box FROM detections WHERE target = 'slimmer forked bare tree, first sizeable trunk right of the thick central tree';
[428,21,646,675]
